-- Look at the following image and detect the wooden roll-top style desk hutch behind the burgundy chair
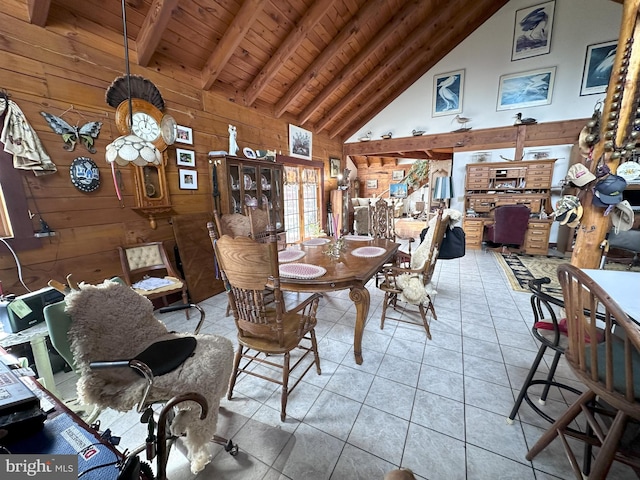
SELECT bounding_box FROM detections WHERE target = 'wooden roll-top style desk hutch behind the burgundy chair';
[464,160,555,255]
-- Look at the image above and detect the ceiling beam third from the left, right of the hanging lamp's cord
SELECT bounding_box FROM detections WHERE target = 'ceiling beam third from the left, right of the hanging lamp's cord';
[202,0,268,90]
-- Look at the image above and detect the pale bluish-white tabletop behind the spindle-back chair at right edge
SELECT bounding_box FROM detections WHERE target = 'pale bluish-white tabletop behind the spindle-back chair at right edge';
[582,268,640,322]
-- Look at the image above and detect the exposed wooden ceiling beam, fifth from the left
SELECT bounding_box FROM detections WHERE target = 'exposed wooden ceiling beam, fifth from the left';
[275,0,387,117]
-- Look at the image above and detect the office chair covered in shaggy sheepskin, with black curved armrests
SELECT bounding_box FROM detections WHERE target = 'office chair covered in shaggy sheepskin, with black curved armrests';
[58,281,237,478]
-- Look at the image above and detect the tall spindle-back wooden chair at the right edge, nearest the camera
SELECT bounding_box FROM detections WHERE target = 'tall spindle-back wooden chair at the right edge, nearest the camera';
[527,264,640,479]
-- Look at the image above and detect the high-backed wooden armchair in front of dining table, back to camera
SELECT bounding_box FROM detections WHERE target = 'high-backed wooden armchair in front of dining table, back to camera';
[207,222,322,422]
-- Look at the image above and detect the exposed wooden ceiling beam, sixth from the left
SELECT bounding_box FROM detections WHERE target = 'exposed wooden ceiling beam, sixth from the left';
[298,2,420,131]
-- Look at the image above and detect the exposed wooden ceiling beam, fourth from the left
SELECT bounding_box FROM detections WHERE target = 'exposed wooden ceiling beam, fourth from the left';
[245,0,335,106]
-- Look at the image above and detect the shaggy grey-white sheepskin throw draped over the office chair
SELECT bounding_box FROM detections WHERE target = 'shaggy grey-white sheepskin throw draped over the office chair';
[66,281,233,473]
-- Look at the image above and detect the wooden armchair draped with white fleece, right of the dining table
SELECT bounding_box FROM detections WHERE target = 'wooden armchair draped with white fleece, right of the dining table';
[378,209,448,339]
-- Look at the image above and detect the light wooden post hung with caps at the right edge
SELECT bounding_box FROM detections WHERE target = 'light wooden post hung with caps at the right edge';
[571,0,640,268]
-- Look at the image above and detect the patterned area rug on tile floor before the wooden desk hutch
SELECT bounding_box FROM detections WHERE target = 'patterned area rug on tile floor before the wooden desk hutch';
[492,252,627,296]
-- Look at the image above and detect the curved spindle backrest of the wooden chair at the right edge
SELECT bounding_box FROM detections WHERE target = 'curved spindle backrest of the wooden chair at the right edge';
[558,264,640,410]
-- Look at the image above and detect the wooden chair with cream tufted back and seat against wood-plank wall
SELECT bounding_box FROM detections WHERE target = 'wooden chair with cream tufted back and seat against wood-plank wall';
[118,242,189,318]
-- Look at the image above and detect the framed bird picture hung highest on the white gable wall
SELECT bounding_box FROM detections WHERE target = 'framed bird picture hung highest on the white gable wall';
[511,1,555,61]
